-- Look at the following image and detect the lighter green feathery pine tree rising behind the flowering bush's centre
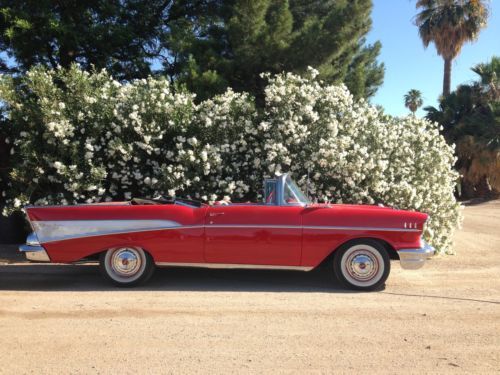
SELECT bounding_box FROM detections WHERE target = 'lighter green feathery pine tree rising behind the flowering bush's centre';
[170,0,384,99]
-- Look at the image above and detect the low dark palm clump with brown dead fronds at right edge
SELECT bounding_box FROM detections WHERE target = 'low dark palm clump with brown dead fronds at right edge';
[425,57,500,197]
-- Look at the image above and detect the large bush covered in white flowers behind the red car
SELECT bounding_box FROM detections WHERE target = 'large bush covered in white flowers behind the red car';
[0,66,460,251]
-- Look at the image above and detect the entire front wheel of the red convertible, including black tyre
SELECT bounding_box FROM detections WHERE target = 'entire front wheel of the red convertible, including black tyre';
[333,239,391,291]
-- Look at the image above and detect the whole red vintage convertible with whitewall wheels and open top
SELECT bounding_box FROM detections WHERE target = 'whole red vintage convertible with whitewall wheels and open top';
[20,174,434,290]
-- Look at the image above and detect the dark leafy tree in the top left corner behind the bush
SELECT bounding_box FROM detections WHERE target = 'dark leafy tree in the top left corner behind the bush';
[0,0,172,78]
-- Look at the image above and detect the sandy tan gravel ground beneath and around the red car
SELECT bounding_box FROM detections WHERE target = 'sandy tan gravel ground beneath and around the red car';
[0,201,500,374]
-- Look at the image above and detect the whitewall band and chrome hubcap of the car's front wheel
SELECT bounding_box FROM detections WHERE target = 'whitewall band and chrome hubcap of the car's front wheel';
[340,244,385,287]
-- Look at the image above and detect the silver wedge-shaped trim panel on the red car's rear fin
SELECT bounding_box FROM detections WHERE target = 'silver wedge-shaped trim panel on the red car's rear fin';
[31,220,181,243]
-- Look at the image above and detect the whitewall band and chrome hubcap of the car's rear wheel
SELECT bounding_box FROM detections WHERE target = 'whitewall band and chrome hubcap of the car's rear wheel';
[104,247,146,283]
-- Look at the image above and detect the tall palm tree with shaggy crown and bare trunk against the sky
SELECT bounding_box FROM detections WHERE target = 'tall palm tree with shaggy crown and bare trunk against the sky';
[415,0,488,96]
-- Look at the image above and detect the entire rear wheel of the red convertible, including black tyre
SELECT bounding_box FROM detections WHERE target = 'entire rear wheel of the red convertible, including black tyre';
[99,247,154,287]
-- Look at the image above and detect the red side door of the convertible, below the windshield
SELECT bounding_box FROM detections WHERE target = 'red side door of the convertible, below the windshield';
[205,204,303,266]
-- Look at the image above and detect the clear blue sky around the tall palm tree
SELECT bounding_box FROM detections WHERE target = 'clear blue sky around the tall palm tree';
[367,0,500,116]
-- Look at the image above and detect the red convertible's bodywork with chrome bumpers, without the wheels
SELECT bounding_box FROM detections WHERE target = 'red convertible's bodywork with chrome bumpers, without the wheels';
[21,176,433,290]
